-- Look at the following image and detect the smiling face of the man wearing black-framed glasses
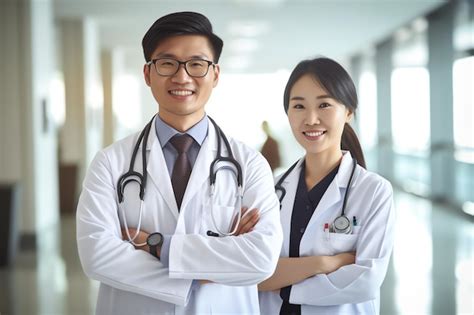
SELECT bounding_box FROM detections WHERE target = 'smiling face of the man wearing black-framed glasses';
[143,35,219,131]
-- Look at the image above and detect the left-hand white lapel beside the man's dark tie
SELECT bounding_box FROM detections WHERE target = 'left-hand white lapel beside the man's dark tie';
[147,118,178,220]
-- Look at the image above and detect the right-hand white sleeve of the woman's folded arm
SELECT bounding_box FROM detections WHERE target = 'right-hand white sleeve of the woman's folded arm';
[290,181,395,305]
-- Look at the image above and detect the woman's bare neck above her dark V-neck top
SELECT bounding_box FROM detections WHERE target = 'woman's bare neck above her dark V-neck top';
[305,148,342,189]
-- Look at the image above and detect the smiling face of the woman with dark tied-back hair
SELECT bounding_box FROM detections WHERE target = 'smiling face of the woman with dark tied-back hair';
[288,74,352,157]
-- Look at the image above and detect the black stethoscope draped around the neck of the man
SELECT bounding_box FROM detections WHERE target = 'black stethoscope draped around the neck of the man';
[117,116,243,246]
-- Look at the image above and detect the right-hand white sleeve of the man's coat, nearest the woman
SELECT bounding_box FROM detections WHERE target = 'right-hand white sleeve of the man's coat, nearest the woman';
[169,154,283,286]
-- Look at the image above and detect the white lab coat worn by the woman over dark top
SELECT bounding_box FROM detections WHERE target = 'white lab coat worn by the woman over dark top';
[259,152,394,315]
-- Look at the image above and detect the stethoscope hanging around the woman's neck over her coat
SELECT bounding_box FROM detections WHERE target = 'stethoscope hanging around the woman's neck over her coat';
[275,158,357,234]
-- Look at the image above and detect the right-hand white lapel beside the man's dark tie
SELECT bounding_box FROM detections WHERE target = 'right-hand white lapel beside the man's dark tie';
[181,121,217,209]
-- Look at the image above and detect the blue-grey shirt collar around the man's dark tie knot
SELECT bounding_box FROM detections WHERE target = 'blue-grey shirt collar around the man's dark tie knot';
[155,115,209,148]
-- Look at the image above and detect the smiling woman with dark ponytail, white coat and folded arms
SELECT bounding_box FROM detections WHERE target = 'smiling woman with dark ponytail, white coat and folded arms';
[259,58,394,314]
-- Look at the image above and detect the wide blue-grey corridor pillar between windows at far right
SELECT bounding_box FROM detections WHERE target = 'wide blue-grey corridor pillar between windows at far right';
[428,4,455,200]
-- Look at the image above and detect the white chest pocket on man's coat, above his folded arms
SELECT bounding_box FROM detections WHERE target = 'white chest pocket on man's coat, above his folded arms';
[200,204,235,234]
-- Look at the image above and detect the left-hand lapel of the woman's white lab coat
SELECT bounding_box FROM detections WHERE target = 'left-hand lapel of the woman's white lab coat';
[280,159,304,257]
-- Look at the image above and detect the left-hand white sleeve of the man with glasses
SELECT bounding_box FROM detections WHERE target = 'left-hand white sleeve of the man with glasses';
[76,151,192,305]
